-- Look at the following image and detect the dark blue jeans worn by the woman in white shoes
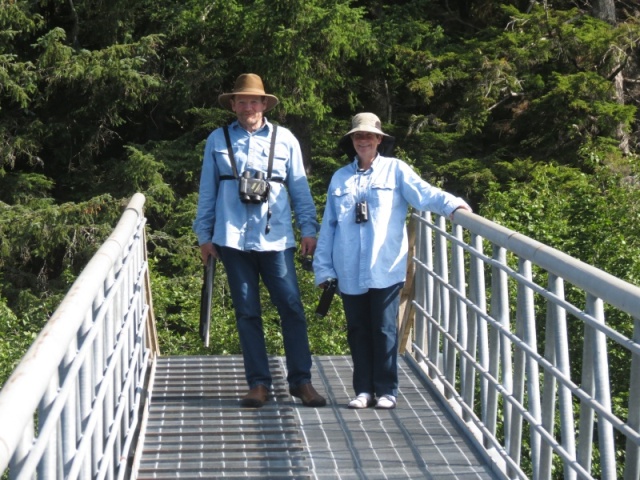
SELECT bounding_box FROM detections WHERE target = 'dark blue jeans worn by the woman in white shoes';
[342,282,404,397]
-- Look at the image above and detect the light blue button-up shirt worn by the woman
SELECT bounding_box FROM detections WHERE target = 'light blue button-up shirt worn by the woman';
[313,155,469,295]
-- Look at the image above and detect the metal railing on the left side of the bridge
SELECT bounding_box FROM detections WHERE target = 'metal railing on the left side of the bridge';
[0,194,154,479]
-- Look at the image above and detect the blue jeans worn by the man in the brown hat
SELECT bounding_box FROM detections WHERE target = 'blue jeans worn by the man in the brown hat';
[216,246,311,389]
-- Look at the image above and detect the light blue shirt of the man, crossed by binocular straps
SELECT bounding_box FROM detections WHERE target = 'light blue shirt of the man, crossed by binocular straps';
[193,119,318,251]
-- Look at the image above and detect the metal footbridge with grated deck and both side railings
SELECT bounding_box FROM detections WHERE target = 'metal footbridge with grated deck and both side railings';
[0,194,640,480]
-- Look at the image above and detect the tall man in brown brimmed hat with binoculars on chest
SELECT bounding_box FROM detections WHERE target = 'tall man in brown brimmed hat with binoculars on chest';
[193,73,326,408]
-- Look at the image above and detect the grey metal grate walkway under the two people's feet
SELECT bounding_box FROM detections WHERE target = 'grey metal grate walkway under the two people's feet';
[137,356,497,480]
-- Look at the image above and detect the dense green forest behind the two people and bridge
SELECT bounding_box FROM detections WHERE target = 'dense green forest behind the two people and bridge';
[0,0,640,406]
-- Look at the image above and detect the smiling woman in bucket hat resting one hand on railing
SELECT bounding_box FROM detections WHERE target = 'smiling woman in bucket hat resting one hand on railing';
[313,113,471,409]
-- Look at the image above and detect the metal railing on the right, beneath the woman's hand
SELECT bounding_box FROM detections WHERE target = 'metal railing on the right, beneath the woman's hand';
[401,210,640,480]
